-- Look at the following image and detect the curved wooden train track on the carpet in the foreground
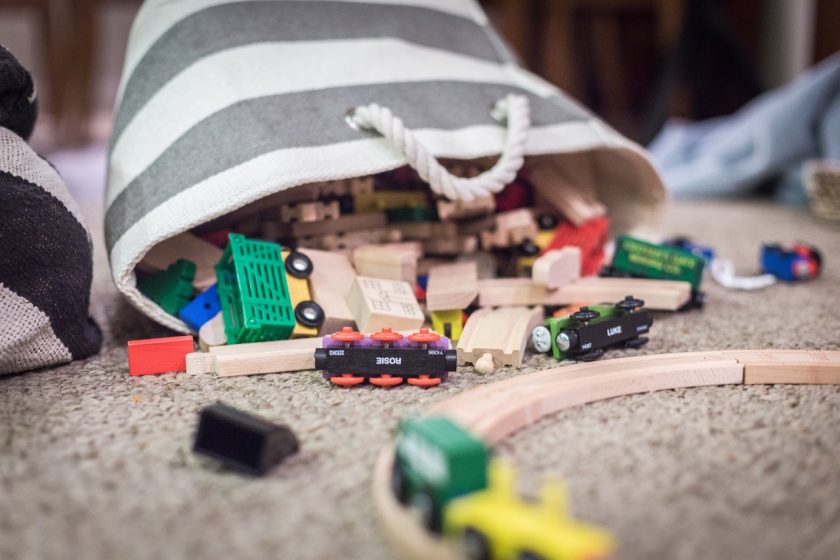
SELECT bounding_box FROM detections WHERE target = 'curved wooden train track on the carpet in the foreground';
[373,350,840,560]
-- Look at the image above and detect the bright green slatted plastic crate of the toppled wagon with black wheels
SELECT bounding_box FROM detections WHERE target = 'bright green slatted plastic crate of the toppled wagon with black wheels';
[216,233,295,344]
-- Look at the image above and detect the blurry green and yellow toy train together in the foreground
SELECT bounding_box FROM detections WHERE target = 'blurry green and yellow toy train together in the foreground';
[391,416,615,560]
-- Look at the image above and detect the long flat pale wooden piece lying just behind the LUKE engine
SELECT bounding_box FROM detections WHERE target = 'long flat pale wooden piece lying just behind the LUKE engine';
[478,276,691,311]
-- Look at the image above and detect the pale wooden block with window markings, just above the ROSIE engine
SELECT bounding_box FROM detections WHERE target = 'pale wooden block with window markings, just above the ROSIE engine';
[347,276,424,333]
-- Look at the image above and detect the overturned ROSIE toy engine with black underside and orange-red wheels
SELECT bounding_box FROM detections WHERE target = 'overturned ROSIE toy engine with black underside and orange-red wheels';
[315,327,458,387]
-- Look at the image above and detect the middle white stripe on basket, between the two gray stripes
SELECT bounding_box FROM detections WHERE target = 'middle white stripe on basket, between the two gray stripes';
[106,39,520,207]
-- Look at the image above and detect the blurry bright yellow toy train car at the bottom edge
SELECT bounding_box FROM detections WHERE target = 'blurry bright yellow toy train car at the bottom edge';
[443,460,615,560]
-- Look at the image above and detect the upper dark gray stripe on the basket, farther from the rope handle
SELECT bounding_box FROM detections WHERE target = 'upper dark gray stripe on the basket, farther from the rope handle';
[111,0,502,145]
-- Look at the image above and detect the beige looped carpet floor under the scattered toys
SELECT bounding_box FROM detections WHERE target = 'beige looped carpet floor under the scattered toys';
[0,199,840,560]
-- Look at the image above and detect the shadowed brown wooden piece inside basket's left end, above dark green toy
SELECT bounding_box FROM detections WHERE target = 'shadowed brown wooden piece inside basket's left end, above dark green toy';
[137,232,222,291]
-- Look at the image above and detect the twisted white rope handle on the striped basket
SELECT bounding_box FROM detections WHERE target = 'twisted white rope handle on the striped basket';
[348,94,531,201]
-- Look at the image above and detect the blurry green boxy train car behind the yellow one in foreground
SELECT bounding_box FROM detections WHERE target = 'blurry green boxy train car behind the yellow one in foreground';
[392,416,490,531]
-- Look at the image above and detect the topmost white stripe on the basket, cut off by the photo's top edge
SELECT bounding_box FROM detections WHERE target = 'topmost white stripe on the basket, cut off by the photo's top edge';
[117,0,487,104]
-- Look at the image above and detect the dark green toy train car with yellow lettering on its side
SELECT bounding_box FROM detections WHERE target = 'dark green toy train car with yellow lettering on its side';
[612,235,706,292]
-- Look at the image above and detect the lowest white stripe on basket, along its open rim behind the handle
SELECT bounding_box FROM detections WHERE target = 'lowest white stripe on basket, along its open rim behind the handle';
[110,121,612,332]
